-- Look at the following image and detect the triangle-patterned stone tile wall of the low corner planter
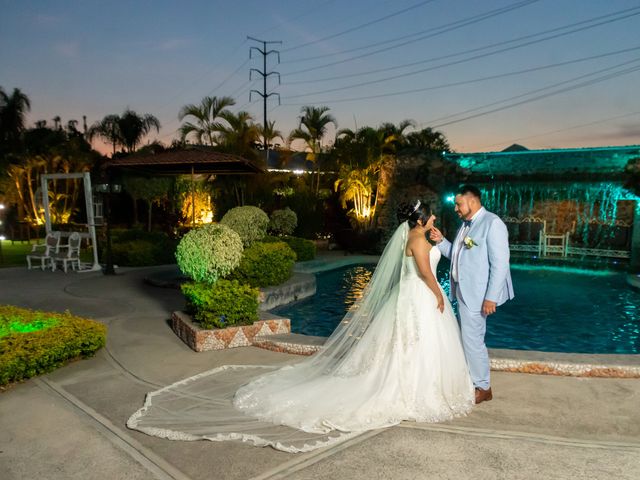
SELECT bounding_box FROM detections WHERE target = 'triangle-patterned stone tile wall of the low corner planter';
[171,311,291,352]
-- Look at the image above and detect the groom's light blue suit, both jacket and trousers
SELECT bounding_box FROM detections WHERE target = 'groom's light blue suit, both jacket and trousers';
[438,208,513,390]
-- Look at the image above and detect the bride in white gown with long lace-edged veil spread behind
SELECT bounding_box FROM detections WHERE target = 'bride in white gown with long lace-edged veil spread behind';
[127,201,474,452]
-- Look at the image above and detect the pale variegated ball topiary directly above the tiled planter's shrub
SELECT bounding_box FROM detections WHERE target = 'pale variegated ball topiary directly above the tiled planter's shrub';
[176,223,242,283]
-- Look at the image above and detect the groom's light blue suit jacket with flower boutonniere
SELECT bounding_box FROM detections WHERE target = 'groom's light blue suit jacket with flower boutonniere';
[438,208,514,311]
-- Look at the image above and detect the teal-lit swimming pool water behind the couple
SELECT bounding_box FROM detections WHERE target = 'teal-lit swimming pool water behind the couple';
[274,261,640,354]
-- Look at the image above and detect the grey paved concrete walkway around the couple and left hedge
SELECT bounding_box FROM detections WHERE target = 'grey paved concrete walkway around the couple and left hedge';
[0,267,640,480]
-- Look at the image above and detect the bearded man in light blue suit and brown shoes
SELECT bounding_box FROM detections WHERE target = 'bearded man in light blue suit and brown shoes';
[430,185,513,404]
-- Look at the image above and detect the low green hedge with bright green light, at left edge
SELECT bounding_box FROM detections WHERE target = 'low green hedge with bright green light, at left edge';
[0,306,107,385]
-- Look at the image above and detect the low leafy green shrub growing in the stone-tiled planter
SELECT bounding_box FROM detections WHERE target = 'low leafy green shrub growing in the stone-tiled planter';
[181,280,260,328]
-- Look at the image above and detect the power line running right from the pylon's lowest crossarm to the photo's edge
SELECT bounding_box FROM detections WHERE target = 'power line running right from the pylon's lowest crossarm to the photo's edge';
[284,45,640,106]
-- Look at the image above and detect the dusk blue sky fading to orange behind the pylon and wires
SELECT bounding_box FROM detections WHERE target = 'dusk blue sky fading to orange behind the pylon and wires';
[0,0,640,152]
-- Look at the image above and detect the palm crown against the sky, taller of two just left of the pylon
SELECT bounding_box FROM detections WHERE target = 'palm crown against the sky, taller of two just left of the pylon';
[178,97,236,146]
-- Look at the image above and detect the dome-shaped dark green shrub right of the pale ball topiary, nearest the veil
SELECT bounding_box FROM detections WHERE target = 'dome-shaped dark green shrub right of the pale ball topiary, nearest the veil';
[230,242,296,287]
